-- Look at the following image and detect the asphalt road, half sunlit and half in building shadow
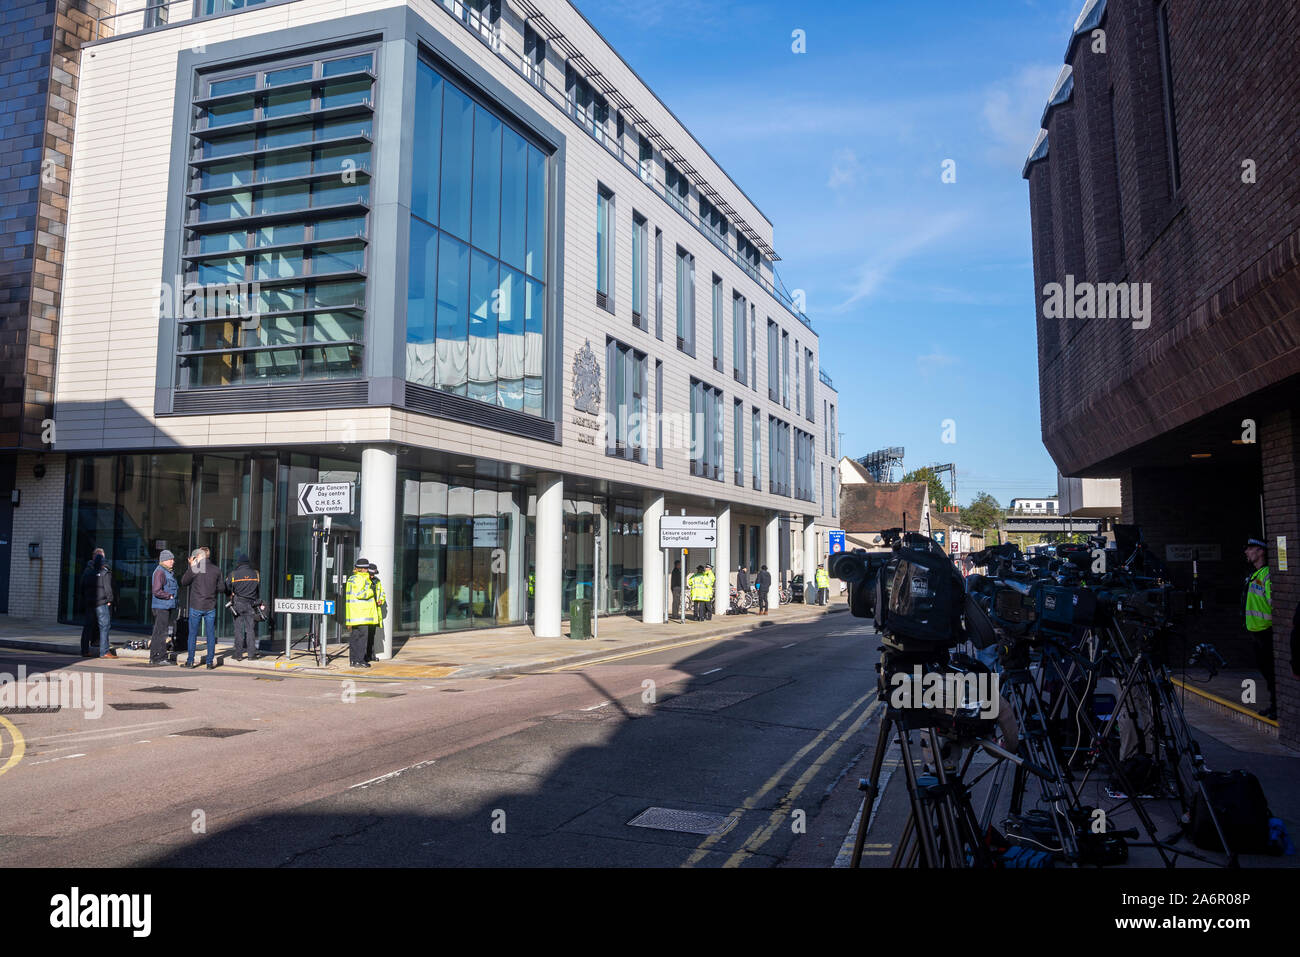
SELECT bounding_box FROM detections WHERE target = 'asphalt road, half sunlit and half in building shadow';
[0,612,879,867]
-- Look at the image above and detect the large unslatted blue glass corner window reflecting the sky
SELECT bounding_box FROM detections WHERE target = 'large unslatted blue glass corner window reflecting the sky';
[407,60,549,416]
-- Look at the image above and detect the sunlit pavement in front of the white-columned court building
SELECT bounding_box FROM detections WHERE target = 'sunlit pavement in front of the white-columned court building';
[0,597,848,679]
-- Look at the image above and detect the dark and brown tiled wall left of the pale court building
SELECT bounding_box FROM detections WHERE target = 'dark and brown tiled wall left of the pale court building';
[0,0,114,449]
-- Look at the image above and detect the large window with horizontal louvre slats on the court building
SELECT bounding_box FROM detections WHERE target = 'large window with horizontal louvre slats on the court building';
[176,51,376,389]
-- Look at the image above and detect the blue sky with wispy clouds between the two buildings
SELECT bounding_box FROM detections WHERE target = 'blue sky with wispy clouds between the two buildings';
[577,0,1083,505]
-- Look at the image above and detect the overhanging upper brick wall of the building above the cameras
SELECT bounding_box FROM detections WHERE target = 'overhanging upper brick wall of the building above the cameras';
[1028,0,1300,475]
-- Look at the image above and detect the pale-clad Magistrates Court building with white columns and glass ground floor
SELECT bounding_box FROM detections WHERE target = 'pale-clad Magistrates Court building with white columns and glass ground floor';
[9,0,839,655]
